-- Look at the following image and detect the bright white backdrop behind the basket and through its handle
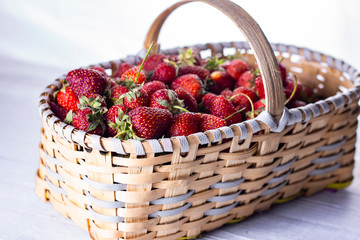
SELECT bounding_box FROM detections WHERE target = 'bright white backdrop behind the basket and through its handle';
[0,0,360,73]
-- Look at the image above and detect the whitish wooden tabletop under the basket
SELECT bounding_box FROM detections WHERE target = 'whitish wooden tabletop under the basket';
[0,54,360,240]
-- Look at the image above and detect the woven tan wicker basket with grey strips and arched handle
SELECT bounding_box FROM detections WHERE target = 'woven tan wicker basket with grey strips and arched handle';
[36,0,360,240]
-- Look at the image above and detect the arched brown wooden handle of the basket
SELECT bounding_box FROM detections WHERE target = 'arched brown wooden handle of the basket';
[144,0,284,120]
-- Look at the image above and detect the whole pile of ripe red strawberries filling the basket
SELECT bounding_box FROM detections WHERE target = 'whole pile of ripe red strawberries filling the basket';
[50,49,313,140]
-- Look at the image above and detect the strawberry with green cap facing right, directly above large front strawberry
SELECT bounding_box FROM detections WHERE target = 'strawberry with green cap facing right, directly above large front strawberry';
[150,89,186,114]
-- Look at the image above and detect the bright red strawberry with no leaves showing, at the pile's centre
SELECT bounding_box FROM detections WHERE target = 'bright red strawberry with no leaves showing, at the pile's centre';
[171,74,203,101]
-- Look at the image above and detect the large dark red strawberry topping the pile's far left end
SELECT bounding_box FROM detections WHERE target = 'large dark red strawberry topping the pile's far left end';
[66,68,107,98]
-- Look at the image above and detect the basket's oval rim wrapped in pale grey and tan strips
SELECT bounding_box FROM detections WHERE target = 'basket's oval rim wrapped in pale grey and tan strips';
[39,42,360,156]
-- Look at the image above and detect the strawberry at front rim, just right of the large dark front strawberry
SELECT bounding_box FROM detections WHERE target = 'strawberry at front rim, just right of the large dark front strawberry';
[168,112,201,137]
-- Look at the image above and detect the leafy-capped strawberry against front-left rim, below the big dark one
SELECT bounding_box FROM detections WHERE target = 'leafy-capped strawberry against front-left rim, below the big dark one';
[73,108,105,135]
